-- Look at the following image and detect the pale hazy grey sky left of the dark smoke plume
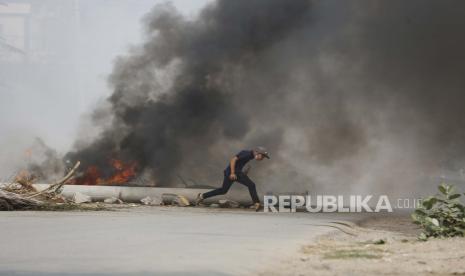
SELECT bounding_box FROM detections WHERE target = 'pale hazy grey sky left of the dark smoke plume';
[0,0,210,176]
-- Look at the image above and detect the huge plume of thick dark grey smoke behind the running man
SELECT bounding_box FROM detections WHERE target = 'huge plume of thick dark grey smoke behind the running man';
[66,0,465,197]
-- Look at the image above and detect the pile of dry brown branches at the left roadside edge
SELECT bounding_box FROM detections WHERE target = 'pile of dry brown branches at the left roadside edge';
[0,161,80,211]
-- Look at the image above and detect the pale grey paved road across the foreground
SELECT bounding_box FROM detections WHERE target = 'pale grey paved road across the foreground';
[0,207,360,276]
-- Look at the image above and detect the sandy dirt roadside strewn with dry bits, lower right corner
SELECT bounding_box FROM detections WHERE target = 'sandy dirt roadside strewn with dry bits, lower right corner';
[262,214,465,276]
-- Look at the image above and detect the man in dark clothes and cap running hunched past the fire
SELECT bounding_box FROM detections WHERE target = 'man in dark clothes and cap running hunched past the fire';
[196,147,270,210]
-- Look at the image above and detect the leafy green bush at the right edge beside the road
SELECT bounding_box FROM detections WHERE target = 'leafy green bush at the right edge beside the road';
[412,184,465,240]
